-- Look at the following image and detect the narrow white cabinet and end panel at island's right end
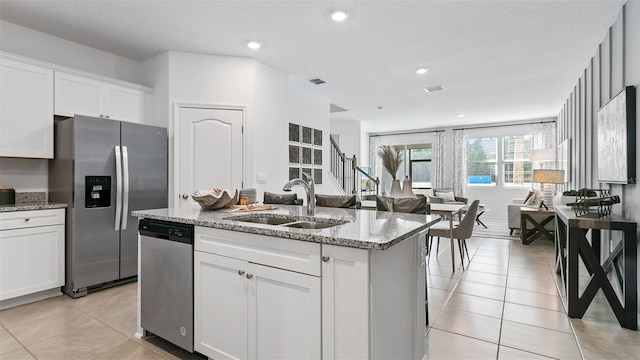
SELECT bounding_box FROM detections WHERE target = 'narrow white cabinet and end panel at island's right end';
[322,232,427,359]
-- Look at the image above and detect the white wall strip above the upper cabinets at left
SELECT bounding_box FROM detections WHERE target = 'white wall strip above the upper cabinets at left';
[0,20,142,85]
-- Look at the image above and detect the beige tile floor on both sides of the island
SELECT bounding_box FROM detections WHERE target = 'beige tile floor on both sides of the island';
[0,229,640,360]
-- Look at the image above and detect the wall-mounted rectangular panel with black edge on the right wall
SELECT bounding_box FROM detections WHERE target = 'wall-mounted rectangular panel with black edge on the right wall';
[597,86,636,184]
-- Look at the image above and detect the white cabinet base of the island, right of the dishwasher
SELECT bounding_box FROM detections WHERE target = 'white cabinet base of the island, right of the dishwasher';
[194,227,427,360]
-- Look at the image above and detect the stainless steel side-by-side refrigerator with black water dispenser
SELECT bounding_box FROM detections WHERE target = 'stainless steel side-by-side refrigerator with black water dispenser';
[49,115,167,298]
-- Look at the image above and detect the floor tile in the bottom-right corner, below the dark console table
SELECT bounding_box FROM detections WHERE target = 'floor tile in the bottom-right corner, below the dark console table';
[570,318,640,359]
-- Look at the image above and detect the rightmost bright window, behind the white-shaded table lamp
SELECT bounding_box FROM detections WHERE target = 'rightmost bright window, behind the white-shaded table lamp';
[502,135,533,185]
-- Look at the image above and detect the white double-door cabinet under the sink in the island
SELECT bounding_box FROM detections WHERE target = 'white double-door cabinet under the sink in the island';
[194,227,321,359]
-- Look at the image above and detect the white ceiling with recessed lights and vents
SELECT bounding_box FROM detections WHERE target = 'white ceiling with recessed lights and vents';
[0,0,624,132]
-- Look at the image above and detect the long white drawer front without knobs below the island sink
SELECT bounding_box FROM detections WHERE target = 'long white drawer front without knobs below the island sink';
[195,226,320,276]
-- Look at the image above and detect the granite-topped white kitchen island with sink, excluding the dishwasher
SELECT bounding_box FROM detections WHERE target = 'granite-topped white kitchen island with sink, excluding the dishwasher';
[133,205,439,359]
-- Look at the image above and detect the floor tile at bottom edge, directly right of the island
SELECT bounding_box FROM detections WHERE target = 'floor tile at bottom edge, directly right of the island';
[427,329,498,360]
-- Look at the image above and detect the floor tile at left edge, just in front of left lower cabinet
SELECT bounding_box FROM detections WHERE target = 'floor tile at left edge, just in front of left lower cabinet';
[0,295,71,329]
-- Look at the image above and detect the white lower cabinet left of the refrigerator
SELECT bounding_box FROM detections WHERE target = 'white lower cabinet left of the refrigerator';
[0,209,65,307]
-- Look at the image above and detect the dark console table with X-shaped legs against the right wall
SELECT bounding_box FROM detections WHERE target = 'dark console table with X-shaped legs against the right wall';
[555,206,638,330]
